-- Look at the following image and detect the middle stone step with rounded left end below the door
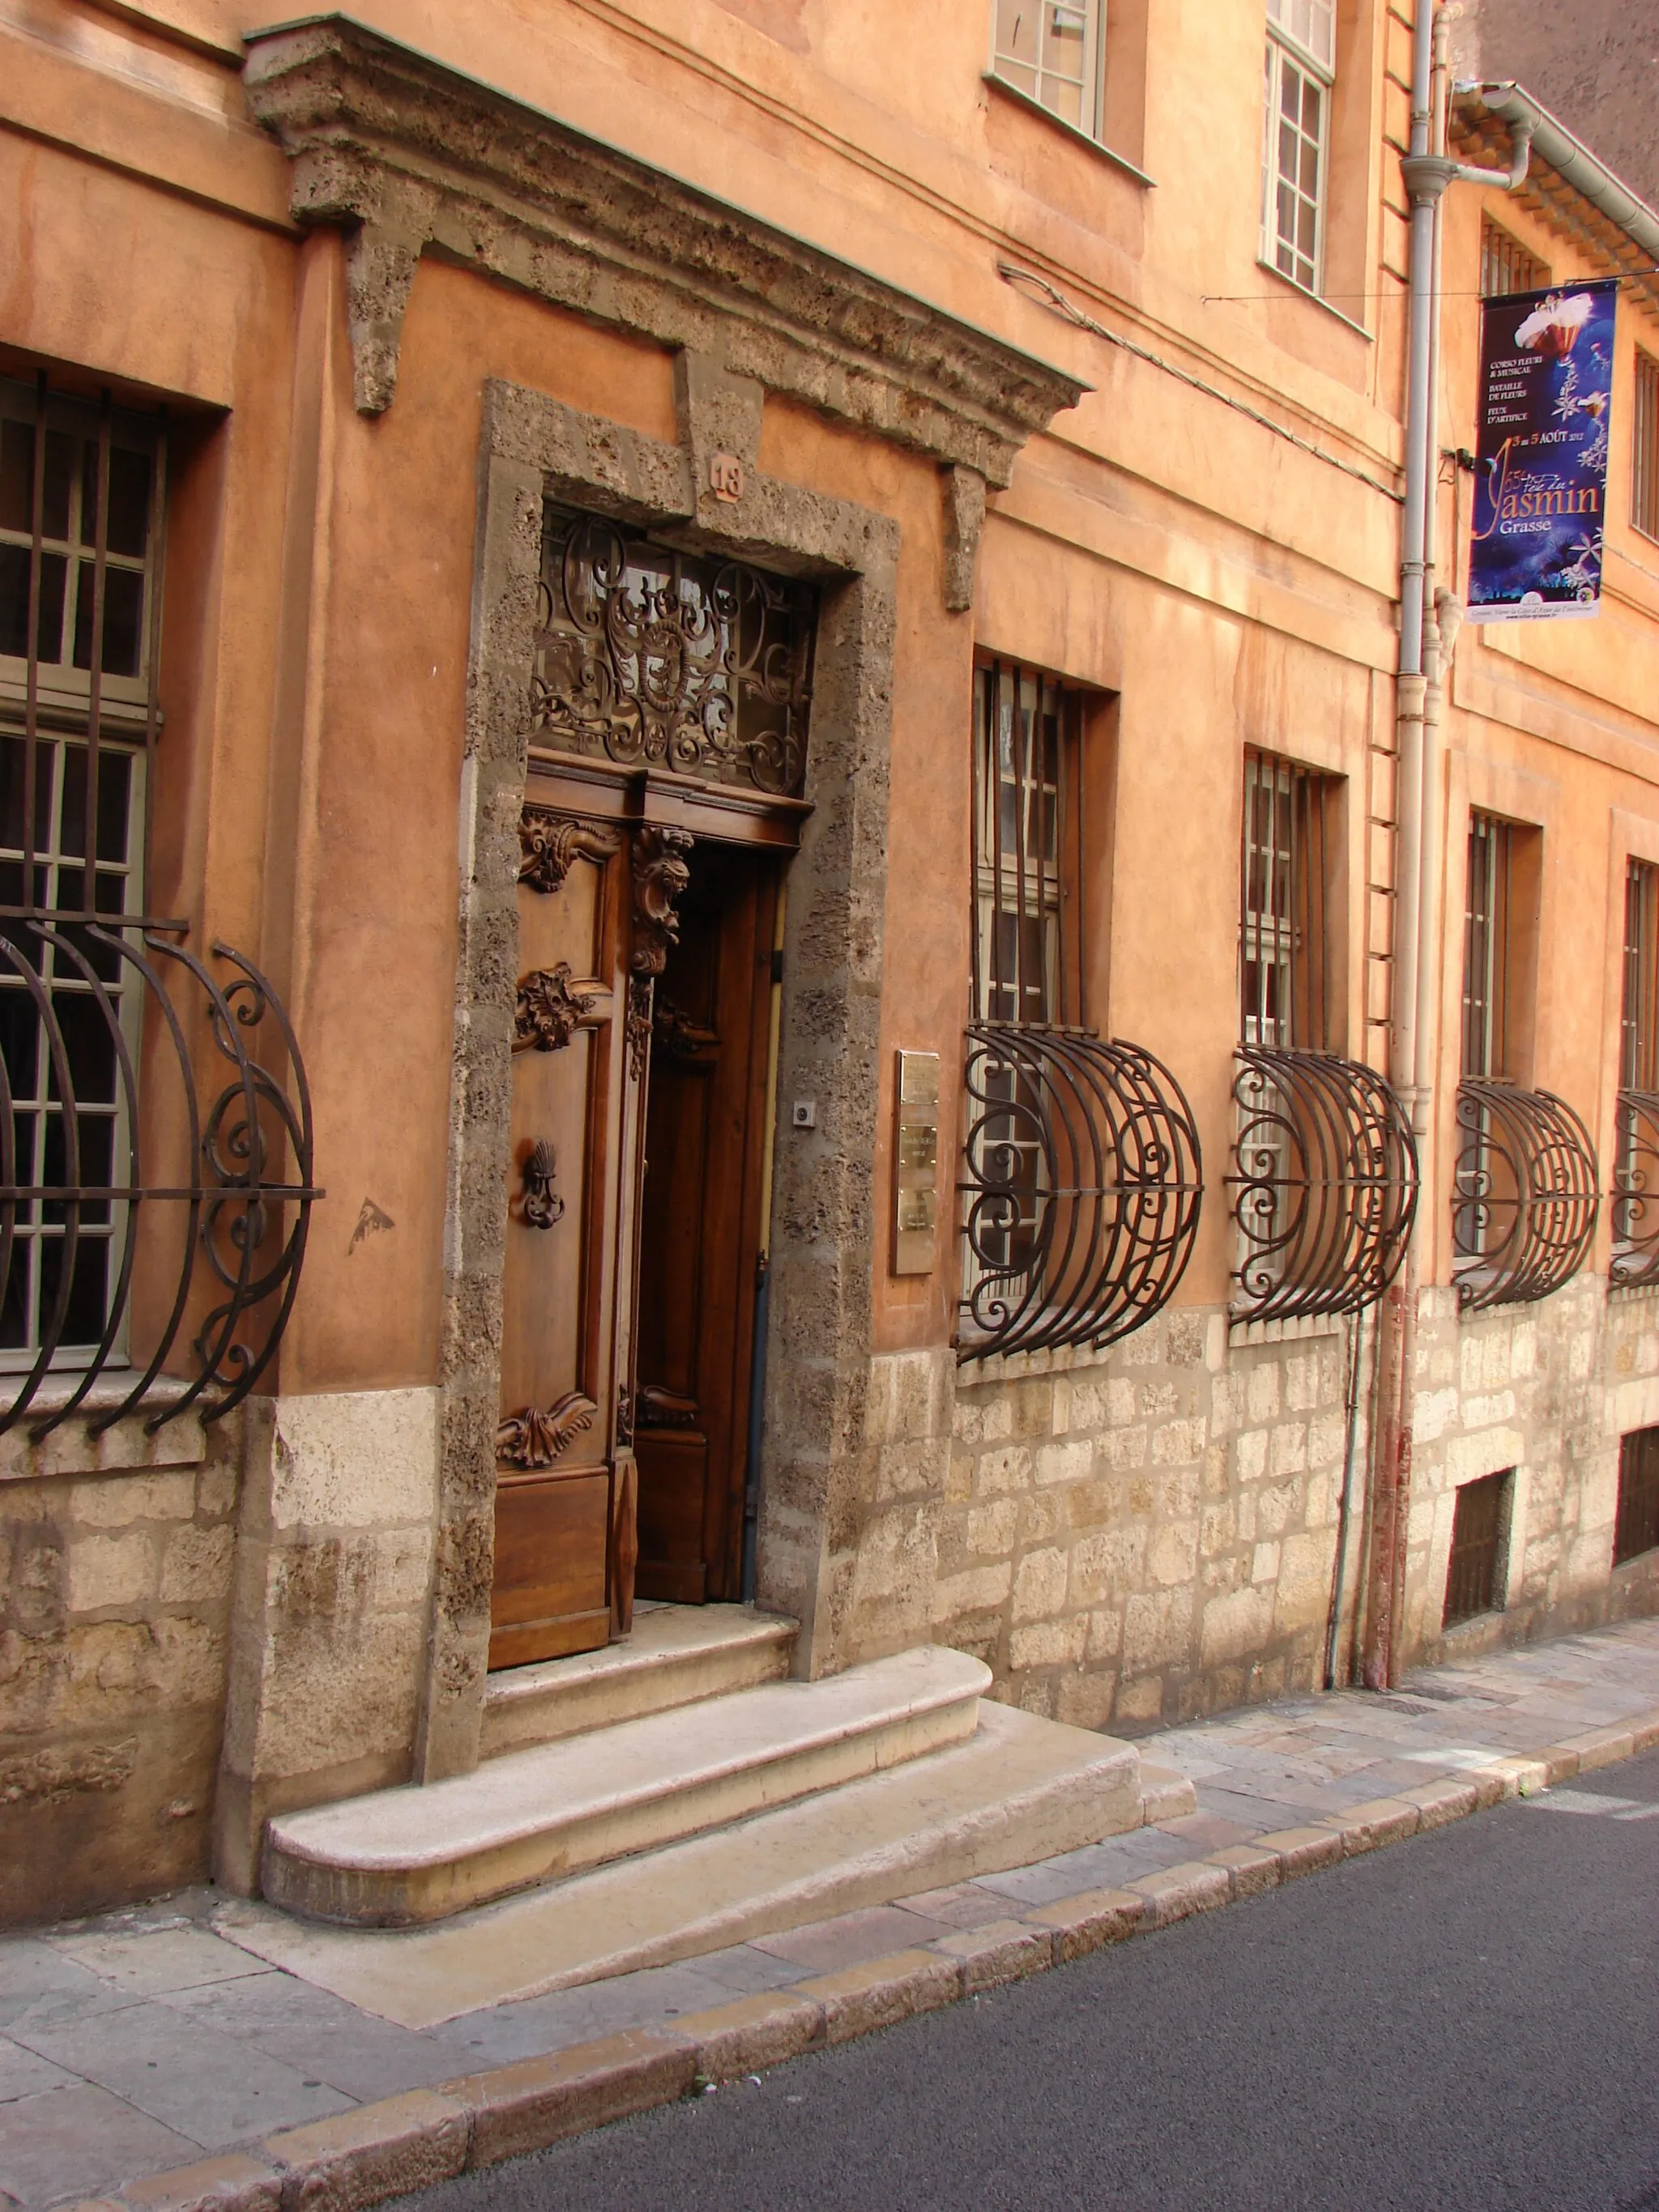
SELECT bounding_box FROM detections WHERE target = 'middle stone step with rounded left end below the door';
[261,1643,991,1927]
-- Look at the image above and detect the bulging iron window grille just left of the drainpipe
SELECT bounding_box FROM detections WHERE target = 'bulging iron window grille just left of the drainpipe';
[1228,1044,1418,1320]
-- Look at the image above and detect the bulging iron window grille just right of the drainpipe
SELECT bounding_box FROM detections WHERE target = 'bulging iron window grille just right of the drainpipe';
[1451,1077,1599,1311]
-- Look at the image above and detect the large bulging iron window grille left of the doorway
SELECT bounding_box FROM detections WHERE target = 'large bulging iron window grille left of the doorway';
[0,918,323,1443]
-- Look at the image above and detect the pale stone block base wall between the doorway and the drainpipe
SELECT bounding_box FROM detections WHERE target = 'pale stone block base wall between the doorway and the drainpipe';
[933,1310,1365,1730]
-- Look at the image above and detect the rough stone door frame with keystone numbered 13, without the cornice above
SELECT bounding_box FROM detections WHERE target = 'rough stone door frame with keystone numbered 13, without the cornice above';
[437,354,898,1779]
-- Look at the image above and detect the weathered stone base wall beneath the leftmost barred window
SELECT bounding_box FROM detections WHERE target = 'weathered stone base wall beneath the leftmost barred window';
[0,1416,228,1927]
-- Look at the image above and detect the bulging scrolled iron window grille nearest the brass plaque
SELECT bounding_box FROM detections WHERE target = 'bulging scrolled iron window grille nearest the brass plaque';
[957,1022,1203,1361]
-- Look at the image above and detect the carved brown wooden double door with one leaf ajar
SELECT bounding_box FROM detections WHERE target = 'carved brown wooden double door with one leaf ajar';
[488,777,794,1668]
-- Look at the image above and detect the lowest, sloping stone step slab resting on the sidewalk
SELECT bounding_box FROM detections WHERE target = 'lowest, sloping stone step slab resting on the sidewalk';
[215,1703,1141,2028]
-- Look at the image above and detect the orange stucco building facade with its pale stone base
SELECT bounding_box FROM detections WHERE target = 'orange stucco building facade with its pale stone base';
[0,0,1659,1920]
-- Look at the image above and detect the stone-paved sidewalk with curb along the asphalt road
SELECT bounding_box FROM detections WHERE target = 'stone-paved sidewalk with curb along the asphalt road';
[0,1622,1659,2212]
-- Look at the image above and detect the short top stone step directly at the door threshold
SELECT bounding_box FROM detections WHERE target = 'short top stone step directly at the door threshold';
[480,1606,799,1758]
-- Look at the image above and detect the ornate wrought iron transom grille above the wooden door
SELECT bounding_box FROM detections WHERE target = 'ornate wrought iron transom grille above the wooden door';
[531,502,817,796]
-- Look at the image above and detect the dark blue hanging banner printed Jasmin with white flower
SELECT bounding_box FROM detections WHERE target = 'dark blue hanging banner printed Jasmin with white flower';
[1469,276,1619,621]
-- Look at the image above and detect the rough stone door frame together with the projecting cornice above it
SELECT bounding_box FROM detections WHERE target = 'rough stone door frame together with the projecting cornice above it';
[234,15,1086,1813]
